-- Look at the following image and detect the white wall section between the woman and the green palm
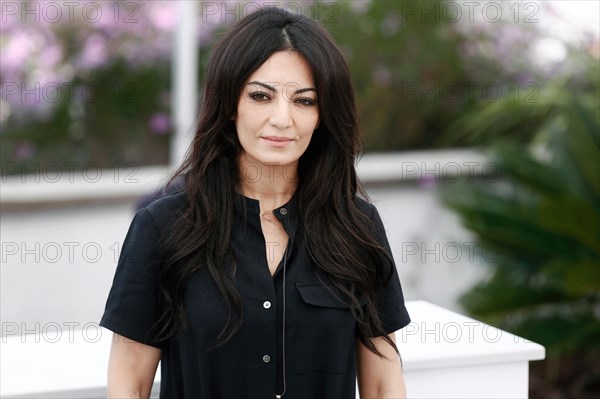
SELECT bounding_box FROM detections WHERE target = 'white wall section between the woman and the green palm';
[368,185,488,311]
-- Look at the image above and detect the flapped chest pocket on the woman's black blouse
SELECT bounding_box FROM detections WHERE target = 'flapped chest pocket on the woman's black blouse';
[294,283,364,373]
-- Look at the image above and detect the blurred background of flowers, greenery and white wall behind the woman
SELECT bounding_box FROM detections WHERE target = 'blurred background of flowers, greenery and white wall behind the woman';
[0,0,600,398]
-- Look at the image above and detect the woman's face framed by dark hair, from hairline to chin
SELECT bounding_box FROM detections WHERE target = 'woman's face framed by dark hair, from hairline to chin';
[233,51,319,166]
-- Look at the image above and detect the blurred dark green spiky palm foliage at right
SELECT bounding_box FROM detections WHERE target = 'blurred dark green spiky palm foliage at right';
[440,57,600,396]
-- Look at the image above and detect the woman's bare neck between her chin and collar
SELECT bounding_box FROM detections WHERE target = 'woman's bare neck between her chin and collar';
[239,155,298,213]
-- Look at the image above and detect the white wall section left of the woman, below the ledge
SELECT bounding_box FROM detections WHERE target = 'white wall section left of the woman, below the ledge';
[0,203,133,334]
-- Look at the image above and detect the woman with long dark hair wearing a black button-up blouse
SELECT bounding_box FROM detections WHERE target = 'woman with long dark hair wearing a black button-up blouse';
[101,8,410,399]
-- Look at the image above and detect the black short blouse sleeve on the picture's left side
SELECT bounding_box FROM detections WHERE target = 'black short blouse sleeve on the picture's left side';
[100,208,161,347]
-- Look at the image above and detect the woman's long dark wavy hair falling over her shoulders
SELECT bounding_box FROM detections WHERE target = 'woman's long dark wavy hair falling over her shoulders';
[157,8,397,355]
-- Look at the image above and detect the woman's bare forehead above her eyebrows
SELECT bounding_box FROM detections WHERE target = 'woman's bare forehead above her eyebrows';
[248,51,314,88]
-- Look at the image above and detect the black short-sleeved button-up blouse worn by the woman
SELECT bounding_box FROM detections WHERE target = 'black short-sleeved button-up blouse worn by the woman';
[100,193,410,399]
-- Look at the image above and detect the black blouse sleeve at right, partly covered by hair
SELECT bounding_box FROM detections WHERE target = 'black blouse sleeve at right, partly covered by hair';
[372,206,410,334]
